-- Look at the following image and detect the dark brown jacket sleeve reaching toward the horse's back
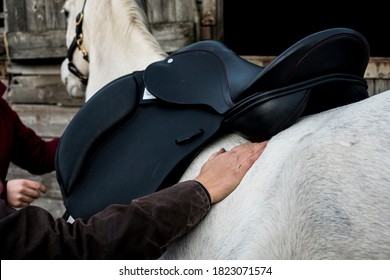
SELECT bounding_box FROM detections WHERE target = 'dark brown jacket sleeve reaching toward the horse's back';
[0,181,210,259]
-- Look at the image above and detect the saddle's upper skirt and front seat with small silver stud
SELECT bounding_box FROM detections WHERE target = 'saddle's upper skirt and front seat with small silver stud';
[144,40,263,114]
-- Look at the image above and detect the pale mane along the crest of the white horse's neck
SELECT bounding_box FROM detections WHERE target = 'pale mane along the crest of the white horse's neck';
[122,0,166,56]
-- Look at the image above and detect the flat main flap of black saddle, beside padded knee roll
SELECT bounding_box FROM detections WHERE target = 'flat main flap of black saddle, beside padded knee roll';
[58,104,222,218]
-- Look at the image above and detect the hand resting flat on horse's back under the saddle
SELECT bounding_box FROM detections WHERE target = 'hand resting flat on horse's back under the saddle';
[195,141,268,203]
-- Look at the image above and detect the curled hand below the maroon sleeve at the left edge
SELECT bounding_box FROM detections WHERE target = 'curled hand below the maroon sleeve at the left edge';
[7,179,46,208]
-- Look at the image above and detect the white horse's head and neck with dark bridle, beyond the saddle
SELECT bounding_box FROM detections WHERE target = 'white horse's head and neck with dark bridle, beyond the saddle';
[61,0,166,100]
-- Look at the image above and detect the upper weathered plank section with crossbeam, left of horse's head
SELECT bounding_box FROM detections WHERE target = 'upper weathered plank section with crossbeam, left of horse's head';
[5,0,66,60]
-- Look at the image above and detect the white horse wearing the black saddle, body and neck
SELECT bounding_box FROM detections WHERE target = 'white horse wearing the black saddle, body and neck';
[60,0,390,259]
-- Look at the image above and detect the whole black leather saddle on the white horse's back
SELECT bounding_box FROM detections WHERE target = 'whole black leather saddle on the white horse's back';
[56,28,369,218]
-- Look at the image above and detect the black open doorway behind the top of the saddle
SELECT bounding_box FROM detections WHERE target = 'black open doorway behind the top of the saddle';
[223,0,390,57]
